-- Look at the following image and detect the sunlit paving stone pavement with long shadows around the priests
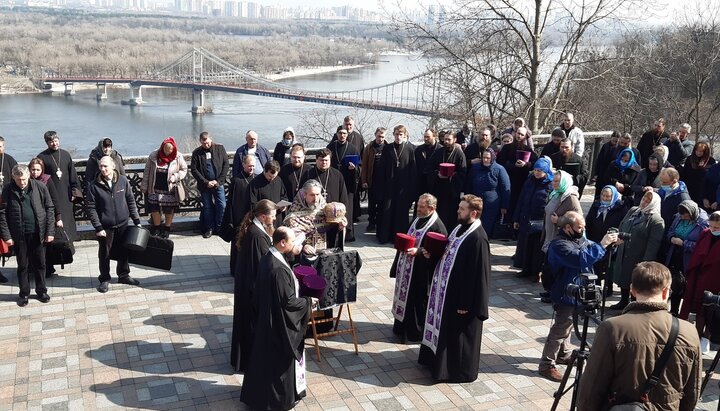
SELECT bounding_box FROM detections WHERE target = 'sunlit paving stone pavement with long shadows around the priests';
[0,209,719,411]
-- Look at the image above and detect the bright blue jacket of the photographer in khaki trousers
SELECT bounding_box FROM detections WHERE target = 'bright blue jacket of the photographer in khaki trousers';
[548,231,605,305]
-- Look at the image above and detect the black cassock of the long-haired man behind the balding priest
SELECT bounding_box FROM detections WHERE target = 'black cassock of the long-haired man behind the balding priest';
[230,223,272,371]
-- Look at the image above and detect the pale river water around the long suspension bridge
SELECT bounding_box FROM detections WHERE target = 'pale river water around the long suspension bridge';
[0,56,427,162]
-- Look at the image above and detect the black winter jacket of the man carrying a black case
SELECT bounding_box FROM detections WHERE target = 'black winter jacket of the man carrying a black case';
[85,171,140,232]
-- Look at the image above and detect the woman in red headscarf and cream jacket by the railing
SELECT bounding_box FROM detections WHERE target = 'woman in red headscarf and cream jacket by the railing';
[140,137,187,238]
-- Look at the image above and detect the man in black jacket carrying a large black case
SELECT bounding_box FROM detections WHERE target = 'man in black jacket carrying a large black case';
[85,156,140,293]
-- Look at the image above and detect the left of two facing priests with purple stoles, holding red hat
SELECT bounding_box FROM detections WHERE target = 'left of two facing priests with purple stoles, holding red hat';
[390,193,447,344]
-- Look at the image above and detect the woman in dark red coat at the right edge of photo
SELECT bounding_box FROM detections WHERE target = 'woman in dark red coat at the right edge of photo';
[680,211,720,348]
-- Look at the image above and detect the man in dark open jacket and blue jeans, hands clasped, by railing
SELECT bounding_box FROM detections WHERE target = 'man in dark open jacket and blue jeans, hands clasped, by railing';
[190,131,230,238]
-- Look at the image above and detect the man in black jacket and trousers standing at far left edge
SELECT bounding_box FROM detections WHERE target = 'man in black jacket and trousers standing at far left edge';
[0,165,55,307]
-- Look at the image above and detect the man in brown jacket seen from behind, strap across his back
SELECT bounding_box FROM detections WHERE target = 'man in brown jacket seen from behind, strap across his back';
[577,262,702,411]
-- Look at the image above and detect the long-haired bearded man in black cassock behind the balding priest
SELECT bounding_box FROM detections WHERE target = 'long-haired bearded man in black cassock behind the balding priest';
[230,200,276,371]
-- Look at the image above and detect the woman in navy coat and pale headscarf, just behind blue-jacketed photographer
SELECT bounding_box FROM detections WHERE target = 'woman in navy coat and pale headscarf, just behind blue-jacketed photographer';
[585,185,627,295]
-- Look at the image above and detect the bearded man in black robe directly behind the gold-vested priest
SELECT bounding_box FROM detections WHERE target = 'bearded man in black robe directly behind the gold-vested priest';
[300,148,352,248]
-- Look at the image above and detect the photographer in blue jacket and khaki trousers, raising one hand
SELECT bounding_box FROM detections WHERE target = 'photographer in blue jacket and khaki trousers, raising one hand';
[539,211,617,381]
